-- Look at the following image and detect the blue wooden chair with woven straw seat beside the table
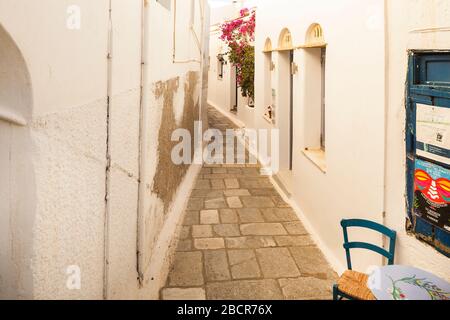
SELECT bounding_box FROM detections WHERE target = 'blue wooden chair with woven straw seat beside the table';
[333,219,397,300]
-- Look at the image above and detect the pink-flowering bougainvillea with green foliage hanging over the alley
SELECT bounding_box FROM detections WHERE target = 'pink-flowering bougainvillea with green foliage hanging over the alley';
[220,9,256,100]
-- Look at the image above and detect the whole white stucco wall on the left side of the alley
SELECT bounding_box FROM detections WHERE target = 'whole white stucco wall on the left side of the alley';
[0,0,208,299]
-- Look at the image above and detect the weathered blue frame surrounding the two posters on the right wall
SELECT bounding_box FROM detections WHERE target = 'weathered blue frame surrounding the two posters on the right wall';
[406,51,450,256]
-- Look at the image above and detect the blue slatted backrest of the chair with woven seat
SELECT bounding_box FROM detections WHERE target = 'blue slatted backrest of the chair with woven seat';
[341,219,397,270]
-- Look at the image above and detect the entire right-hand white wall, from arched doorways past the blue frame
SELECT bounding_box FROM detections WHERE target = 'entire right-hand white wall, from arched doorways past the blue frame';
[255,0,450,279]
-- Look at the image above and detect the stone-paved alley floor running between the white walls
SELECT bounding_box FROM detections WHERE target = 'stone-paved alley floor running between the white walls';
[161,108,337,300]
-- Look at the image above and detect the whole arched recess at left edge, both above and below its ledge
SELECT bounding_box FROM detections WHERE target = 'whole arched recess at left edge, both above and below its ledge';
[0,25,36,299]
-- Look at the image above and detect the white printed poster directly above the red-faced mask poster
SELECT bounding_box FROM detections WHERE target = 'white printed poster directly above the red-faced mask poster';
[417,104,450,165]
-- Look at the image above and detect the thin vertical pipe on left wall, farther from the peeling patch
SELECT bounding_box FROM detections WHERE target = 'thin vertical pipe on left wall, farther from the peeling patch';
[103,0,113,300]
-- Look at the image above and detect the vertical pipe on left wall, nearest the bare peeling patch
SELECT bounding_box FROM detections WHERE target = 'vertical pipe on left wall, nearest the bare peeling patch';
[136,0,150,287]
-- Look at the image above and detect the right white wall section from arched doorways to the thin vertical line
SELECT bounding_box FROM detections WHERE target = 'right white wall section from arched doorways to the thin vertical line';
[255,0,385,271]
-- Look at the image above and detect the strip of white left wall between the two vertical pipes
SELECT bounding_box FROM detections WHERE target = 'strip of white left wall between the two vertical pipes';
[107,0,142,299]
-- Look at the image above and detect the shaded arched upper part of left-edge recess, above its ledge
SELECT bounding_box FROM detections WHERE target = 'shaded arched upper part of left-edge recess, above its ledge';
[0,25,32,126]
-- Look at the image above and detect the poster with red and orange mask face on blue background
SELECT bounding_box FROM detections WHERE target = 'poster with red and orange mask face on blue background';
[414,160,450,232]
